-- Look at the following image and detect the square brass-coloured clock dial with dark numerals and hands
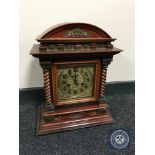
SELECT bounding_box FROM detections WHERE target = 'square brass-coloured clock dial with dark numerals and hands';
[57,65,95,102]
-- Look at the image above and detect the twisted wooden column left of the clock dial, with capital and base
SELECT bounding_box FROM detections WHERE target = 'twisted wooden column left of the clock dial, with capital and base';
[40,62,54,109]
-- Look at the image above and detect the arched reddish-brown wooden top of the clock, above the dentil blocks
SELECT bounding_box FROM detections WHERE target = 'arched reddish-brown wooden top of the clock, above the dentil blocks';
[36,23,115,42]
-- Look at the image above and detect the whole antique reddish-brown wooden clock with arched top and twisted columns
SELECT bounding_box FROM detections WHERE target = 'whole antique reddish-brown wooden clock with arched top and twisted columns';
[30,23,122,135]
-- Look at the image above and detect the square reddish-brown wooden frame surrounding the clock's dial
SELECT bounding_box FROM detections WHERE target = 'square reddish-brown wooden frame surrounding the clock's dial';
[52,60,100,105]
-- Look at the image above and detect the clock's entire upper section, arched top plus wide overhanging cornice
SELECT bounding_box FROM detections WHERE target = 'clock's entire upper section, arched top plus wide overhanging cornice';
[31,23,122,59]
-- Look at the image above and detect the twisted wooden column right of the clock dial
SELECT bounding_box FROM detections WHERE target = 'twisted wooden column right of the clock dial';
[99,59,112,103]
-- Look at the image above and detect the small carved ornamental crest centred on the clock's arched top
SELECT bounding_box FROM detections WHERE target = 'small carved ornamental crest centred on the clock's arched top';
[65,28,90,38]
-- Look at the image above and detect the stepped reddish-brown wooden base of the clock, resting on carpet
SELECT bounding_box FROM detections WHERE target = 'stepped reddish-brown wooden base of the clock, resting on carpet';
[36,105,114,135]
